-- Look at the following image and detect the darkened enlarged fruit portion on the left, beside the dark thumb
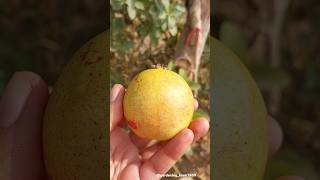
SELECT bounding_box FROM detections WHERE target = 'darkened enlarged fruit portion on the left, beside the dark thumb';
[43,32,109,180]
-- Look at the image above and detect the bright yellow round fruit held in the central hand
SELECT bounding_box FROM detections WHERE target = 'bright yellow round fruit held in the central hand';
[123,68,194,140]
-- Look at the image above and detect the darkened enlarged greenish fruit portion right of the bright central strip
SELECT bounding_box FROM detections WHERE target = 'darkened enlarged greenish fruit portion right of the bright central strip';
[210,38,267,180]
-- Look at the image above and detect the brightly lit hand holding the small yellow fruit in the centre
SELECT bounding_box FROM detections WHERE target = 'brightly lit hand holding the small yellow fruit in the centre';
[110,85,209,180]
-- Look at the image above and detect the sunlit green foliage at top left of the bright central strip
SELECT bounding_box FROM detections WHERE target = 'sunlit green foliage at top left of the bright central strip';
[110,0,186,53]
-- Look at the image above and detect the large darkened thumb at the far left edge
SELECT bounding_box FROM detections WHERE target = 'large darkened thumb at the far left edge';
[0,72,49,180]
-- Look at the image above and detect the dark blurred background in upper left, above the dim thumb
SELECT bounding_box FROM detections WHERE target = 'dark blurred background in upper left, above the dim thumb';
[0,0,107,89]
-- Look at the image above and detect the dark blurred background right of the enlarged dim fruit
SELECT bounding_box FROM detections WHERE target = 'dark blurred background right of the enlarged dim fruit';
[211,0,320,180]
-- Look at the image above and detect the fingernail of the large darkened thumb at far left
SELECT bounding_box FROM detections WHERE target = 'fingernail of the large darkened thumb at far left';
[0,72,40,128]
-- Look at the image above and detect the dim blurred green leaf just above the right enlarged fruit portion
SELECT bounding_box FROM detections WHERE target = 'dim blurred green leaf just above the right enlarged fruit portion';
[220,22,248,61]
